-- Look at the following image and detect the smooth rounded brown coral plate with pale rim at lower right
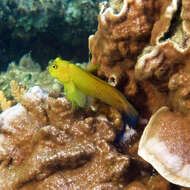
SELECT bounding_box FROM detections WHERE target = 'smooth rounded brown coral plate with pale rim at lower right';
[138,107,190,187]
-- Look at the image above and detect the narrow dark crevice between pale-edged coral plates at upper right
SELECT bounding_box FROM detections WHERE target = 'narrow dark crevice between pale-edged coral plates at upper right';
[159,0,182,42]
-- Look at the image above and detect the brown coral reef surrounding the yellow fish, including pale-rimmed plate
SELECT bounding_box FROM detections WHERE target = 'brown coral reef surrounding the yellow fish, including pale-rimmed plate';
[0,0,190,190]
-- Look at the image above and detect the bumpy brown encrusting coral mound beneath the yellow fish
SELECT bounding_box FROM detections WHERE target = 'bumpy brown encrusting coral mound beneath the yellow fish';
[0,84,130,190]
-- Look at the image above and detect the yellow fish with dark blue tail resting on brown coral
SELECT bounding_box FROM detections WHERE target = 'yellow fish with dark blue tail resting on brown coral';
[48,58,138,126]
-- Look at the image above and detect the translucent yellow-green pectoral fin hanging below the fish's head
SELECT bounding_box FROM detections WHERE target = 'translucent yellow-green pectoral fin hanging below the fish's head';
[64,82,86,109]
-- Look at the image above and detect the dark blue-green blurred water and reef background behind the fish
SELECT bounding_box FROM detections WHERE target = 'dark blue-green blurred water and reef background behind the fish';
[0,0,101,71]
